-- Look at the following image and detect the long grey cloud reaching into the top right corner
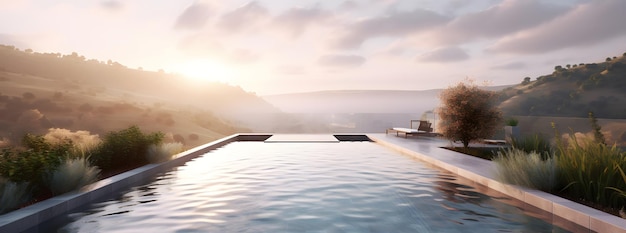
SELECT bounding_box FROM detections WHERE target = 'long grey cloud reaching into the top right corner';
[487,0,626,54]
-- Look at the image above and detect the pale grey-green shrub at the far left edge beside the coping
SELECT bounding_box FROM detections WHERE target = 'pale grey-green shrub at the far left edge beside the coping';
[0,177,31,214]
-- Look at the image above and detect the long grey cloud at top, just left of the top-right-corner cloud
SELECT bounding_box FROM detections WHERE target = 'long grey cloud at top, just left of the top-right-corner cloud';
[436,0,569,44]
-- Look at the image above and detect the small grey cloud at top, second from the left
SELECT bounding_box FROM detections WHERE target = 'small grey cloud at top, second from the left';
[217,1,269,32]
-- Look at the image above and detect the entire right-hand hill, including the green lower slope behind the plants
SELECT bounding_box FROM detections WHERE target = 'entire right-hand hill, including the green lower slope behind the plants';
[499,53,626,146]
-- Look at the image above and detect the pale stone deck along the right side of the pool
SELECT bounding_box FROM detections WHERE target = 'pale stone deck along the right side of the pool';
[367,134,626,232]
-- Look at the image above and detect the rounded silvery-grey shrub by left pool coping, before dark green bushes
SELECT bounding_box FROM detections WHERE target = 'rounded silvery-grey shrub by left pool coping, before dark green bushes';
[45,158,100,195]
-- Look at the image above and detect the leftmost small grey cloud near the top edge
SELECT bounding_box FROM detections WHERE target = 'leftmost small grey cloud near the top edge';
[174,2,213,29]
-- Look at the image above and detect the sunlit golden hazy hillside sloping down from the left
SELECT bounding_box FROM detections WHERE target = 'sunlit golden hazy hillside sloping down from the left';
[0,46,280,146]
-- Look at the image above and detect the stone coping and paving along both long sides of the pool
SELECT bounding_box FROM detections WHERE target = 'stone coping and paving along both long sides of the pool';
[0,133,626,232]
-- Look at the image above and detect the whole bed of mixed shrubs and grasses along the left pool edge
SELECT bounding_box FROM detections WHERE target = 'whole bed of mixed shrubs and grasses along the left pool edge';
[0,126,182,214]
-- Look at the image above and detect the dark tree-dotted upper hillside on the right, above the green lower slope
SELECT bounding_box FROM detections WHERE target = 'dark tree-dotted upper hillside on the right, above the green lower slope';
[500,53,626,119]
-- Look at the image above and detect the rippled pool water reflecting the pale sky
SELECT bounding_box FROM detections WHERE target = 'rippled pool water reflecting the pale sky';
[55,142,566,232]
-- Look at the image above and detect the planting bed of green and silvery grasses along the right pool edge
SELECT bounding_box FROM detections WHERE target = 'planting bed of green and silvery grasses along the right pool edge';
[494,114,626,213]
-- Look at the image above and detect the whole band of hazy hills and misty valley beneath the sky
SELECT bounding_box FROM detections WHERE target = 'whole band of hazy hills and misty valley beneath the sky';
[0,46,626,146]
